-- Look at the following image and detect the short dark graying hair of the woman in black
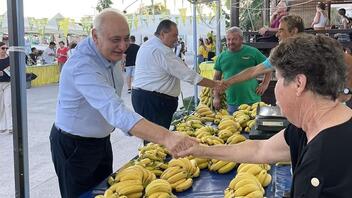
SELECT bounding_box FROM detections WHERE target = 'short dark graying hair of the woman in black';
[270,33,346,100]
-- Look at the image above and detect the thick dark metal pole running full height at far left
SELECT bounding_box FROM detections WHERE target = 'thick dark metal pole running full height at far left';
[7,0,29,197]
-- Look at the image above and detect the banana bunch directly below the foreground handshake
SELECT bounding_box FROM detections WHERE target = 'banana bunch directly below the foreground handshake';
[160,158,200,192]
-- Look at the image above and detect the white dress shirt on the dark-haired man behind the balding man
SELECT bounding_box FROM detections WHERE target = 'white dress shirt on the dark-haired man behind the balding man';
[132,36,203,97]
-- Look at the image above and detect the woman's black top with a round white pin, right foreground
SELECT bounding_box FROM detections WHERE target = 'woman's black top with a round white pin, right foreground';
[284,118,352,198]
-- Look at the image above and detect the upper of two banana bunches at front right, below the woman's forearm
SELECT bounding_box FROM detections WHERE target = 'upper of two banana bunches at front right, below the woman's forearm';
[237,164,271,187]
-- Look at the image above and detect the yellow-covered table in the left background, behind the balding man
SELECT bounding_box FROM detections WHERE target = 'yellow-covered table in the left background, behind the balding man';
[26,64,60,87]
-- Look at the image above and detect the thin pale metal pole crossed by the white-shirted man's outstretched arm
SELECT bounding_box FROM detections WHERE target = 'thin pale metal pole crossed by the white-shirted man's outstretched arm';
[193,2,198,109]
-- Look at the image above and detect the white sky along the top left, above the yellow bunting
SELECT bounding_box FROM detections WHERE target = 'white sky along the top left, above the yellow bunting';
[0,0,190,20]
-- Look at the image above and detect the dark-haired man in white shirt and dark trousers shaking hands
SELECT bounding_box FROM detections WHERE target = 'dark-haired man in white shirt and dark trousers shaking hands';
[132,20,225,128]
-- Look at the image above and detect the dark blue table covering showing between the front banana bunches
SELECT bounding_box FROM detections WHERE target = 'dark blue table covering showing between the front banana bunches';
[81,166,291,198]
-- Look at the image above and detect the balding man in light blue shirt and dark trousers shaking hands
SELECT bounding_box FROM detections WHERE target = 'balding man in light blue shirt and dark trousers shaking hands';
[50,9,197,197]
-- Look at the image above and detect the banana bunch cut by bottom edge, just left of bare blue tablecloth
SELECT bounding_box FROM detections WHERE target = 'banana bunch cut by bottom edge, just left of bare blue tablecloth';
[145,179,175,198]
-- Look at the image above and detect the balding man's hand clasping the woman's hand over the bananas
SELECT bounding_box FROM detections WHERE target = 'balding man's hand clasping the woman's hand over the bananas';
[165,132,199,157]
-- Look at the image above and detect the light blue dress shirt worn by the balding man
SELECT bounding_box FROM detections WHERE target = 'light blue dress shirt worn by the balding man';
[55,38,142,138]
